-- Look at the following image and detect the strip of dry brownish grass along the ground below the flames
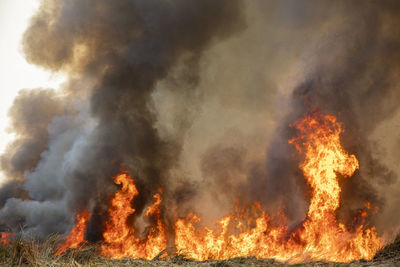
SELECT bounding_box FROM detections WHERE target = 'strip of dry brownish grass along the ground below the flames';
[0,235,400,267]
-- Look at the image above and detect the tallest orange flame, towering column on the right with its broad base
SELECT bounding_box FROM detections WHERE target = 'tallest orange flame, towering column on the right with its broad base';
[289,112,381,262]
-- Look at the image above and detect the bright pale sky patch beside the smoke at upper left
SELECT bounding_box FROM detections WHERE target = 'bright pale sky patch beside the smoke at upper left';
[0,0,64,182]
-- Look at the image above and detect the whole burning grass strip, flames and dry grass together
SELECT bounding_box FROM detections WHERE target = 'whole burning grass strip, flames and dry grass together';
[2,112,384,266]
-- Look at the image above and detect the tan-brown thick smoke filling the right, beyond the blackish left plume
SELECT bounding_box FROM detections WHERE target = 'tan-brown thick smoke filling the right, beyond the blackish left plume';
[169,1,400,231]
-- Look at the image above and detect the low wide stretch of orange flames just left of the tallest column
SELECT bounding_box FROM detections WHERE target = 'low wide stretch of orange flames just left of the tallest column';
[175,204,292,261]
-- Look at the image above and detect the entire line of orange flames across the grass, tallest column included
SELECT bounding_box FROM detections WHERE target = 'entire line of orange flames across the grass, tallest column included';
[58,112,382,263]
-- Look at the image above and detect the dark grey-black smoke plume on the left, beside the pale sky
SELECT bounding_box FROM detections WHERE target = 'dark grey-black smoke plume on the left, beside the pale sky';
[0,0,243,237]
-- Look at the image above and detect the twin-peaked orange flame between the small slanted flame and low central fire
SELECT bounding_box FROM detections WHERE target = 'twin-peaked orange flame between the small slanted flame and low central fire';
[101,174,167,259]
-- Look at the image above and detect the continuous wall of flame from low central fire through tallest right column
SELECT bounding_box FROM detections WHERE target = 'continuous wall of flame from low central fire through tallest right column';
[175,112,382,263]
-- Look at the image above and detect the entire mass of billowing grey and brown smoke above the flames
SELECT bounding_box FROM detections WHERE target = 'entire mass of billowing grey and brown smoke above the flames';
[0,0,400,243]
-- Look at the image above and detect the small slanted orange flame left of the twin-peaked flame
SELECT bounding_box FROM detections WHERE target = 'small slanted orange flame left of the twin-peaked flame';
[55,210,90,256]
